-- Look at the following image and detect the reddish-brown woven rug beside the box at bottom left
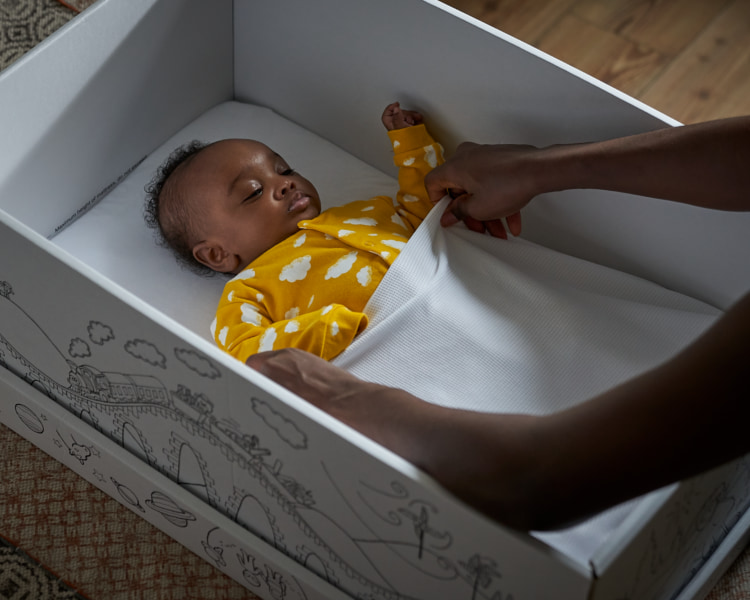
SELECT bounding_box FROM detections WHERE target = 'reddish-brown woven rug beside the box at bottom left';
[0,425,257,600]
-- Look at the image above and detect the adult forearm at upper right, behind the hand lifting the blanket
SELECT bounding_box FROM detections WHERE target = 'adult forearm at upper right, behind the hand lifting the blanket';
[538,117,750,210]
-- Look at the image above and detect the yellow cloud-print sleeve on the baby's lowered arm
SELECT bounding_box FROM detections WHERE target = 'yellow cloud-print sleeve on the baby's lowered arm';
[212,300,367,362]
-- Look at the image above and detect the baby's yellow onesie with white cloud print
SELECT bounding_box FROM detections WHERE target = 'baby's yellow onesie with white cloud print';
[211,125,443,362]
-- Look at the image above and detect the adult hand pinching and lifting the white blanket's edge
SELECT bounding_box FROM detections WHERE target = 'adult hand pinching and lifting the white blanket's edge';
[425,142,541,238]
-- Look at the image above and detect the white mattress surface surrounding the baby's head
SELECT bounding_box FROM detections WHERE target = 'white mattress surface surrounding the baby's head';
[52,102,398,341]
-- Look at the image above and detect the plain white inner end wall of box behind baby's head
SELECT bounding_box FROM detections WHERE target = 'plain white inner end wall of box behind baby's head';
[0,0,233,236]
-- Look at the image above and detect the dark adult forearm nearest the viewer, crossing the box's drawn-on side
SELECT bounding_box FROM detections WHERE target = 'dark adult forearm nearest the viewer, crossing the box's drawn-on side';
[418,295,750,529]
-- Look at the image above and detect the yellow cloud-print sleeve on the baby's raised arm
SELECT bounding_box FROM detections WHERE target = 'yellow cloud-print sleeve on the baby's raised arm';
[388,124,445,228]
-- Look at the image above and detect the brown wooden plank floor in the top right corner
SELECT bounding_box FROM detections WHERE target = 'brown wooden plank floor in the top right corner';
[444,0,750,123]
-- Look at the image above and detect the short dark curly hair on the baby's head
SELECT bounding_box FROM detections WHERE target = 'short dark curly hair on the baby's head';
[144,140,215,275]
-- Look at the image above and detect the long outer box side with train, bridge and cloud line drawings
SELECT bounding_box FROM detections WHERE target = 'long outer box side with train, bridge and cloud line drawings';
[0,220,590,599]
